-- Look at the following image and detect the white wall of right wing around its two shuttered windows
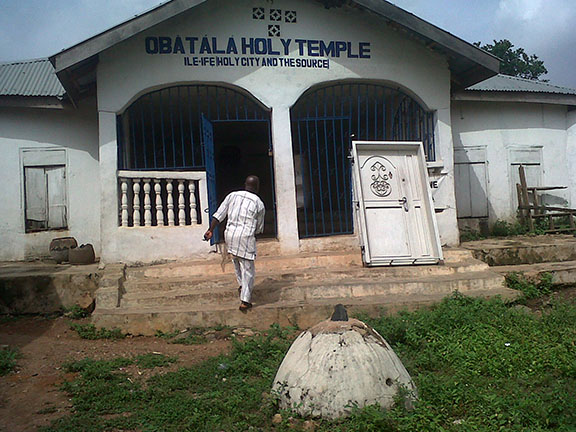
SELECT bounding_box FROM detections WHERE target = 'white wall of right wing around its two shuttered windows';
[452,101,575,223]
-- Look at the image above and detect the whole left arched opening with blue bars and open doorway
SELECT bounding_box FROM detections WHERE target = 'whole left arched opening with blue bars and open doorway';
[117,84,276,237]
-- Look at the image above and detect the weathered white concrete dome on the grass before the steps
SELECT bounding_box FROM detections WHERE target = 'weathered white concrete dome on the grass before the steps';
[272,319,417,420]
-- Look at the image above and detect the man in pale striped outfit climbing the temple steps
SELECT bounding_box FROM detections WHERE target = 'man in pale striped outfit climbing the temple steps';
[204,175,265,312]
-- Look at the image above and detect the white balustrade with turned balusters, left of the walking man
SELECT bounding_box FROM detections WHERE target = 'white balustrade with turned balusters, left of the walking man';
[118,171,207,228]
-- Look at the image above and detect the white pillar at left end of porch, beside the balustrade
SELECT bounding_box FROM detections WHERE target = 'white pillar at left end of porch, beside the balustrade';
[98,111,119,264]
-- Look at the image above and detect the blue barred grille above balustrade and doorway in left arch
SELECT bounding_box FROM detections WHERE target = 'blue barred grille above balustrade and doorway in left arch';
[118,84,270,170]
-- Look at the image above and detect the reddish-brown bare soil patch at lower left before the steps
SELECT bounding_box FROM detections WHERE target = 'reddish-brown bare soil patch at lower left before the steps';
[0,317,231,432]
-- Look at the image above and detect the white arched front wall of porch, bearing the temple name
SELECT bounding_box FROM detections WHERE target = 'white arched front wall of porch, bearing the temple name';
[98,0,458,261]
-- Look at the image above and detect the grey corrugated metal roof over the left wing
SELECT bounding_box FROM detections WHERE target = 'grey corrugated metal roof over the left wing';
[0,59,66,97]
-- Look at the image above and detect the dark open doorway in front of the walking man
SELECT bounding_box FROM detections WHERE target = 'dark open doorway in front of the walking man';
[213,121,276,237]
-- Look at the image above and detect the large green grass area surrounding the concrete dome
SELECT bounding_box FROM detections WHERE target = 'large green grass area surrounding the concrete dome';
[44,295,576,432]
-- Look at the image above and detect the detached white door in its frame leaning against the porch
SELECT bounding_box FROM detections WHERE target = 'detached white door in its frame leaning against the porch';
[352,141,442,266]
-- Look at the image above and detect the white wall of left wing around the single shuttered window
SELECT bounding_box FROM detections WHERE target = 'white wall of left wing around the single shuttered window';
[0,100,100,260]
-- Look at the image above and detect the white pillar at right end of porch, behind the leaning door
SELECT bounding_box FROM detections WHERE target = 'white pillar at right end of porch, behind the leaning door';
[434,107,460,246]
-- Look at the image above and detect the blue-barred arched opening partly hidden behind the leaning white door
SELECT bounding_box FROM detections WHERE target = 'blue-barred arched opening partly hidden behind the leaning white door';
[290,82,435,238]
